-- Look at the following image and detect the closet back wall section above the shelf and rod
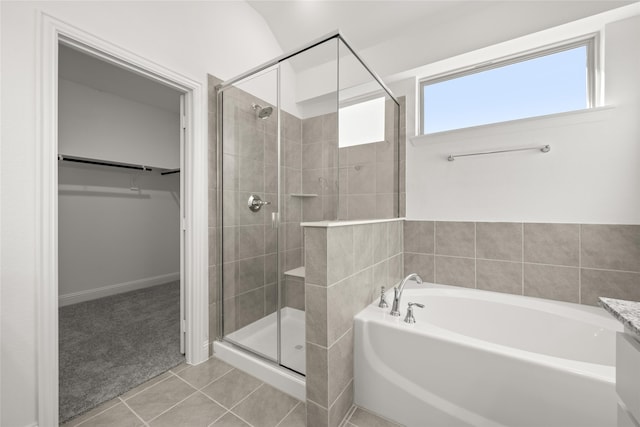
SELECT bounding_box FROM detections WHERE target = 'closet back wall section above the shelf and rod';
[58,79,180,169]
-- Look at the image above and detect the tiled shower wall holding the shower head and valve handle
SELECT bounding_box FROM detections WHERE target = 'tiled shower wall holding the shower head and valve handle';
[221,88,277,334]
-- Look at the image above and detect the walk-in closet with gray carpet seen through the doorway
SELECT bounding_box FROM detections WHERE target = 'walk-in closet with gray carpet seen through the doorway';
[58,45,184,422]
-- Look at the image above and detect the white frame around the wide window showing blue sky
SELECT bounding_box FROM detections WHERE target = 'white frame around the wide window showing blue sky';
[418,33,601,135]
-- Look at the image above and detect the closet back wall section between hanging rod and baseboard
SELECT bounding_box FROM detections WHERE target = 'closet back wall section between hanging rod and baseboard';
[58,163,180,304]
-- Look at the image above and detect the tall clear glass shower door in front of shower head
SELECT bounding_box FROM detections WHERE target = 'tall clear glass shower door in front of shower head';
[221,67,279,362]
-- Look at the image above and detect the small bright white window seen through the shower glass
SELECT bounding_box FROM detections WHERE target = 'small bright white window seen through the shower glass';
[338,97,385,148]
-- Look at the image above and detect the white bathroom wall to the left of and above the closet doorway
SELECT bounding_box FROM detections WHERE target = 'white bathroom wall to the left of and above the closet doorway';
[0,1,282,427]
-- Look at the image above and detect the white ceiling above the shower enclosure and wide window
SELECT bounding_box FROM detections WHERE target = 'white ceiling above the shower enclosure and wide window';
[248,0,636,77]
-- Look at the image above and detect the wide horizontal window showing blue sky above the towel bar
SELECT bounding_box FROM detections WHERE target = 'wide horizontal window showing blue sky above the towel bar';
[420,37,595,134]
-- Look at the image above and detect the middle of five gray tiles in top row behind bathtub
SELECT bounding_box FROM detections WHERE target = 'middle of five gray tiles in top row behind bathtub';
[476,222,522,261]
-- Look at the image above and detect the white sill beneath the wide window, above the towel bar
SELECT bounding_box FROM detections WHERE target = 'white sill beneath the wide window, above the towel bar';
[409,105,615,147]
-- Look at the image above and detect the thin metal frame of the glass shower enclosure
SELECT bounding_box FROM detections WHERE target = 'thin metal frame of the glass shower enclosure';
[215,30,400,374]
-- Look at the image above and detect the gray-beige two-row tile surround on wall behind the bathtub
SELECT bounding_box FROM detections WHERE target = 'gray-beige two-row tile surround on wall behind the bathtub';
[404,220,640,305]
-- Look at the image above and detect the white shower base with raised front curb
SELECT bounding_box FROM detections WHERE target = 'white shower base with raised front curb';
[213,307,305,400]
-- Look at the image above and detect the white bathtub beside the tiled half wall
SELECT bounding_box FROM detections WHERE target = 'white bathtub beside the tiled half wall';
[354,285,622,427]
